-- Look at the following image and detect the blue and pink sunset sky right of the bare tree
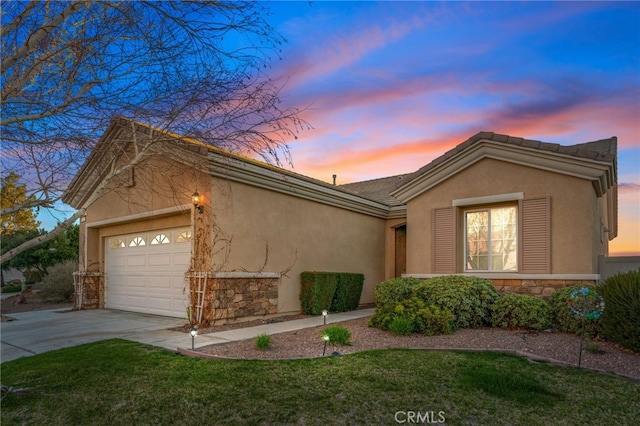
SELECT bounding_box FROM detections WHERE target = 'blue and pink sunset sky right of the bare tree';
[267,1,640,255]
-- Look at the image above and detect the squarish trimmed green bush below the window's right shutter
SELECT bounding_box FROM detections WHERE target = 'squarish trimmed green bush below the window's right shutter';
[491,294,551,330]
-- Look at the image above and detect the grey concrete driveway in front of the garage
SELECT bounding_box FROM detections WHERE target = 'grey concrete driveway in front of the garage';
[0,309,195,362]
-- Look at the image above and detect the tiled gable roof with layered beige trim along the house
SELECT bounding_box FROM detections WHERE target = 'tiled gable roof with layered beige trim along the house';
[62,117,617,230]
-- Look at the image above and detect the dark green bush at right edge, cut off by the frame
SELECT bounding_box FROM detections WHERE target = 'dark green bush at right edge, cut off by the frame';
[597,271,640,352]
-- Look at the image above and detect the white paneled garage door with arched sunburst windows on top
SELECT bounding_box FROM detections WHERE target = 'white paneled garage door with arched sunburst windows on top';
[105,228,191,317]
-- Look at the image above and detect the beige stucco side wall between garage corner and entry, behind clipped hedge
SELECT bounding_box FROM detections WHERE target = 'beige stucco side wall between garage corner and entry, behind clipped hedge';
[212,179,385,312]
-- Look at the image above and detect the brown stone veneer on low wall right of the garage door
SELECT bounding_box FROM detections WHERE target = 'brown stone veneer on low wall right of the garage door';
[190,274,280,326]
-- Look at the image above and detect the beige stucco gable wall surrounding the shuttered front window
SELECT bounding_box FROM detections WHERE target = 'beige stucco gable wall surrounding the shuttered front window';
[407,159,601,274]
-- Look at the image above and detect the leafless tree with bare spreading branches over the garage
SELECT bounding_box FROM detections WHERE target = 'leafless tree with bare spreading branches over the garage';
[0,0,308,261]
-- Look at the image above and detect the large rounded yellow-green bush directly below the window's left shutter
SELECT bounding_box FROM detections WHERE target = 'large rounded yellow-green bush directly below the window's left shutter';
[413,275,500,328]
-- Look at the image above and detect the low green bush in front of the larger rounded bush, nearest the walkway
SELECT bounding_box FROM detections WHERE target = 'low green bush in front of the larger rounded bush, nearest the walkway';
[369,297,456,336]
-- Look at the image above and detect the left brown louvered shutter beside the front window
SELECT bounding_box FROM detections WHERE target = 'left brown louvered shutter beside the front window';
[433,207,456,274]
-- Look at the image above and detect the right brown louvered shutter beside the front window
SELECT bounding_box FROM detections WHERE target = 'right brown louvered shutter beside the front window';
[519,197,551,274]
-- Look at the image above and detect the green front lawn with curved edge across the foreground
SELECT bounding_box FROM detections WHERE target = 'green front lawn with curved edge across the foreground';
[0,340,640,426]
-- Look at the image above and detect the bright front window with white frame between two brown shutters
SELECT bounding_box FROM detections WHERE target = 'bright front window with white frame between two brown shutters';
[464,206,518,271]
